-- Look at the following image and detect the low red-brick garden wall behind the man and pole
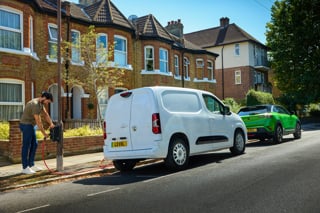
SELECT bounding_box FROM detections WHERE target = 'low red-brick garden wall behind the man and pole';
[0,120,103,163]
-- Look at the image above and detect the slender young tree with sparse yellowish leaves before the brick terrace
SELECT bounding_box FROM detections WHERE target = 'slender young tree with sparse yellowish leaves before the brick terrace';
[64,26,125,120]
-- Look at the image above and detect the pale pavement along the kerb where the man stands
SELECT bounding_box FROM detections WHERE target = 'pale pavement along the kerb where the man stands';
[0,123,320,191]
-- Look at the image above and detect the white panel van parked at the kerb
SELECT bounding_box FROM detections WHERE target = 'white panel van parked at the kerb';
[103,86,247,171]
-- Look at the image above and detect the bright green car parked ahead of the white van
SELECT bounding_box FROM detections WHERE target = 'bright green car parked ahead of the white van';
[238,104,301,143]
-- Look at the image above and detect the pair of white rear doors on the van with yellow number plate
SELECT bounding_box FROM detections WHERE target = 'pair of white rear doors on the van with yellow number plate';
[105,88,161,151]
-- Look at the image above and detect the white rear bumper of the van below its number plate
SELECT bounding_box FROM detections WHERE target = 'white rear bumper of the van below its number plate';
[103,146,167,160]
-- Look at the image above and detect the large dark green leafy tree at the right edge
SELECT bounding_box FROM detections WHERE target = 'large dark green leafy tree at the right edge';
[266,0,320,104]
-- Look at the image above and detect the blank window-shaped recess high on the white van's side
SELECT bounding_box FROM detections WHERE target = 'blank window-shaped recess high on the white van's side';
[162,91,201,112]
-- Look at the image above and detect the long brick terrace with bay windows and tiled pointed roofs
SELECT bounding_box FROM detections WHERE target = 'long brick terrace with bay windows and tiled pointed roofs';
[0,0,219,120]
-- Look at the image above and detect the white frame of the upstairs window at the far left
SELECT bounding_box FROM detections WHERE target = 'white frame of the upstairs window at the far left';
[0,6,23,52]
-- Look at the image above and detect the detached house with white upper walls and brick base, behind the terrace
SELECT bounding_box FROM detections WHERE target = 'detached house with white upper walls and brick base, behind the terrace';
[184,17,272,100]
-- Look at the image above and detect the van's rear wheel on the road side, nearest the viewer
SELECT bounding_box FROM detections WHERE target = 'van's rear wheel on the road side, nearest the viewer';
[165,137,189,170]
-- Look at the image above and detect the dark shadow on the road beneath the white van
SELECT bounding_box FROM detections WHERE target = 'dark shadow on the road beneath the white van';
[74,151,234,185]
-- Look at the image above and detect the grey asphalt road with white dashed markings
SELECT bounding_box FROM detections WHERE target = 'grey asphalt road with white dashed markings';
[0,130,320,213]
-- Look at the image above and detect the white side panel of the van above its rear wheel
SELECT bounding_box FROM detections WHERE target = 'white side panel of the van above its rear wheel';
[158,90,212,153]
